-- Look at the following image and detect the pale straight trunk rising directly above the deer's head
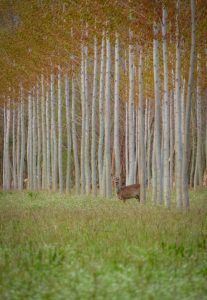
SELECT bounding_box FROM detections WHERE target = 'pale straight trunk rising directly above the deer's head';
[114,33,121,182]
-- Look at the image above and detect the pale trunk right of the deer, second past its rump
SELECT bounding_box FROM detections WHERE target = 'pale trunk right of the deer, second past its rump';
[153,23,162,203]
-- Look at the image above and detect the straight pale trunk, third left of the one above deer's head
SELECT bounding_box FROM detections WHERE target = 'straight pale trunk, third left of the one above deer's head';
[91,38,97,196]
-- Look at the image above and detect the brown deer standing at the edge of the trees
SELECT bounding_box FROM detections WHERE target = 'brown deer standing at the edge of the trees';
[114,177,140,203]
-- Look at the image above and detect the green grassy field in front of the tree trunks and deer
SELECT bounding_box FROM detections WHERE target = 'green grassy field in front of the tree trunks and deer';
[0,190,207,300]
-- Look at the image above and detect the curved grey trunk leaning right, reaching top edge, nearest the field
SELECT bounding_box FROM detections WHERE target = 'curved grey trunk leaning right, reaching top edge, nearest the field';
[182,0,196,208]
